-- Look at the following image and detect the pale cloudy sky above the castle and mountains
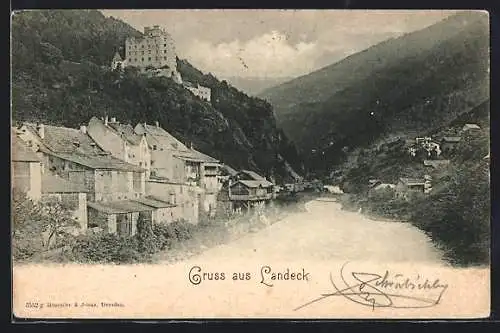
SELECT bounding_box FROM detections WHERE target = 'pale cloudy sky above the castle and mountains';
[102,10,455,78]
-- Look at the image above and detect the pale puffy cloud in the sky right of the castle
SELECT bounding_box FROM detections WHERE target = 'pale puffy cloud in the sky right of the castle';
[183,31,318,77]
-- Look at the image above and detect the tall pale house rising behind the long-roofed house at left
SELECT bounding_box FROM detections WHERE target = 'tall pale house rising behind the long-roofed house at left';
[87,116,151,179]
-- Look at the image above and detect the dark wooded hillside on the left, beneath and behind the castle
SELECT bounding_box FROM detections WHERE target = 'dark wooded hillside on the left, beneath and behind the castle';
[12,10,300,181]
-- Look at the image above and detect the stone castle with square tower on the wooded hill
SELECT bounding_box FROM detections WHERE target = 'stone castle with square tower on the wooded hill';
[111,25,211,102]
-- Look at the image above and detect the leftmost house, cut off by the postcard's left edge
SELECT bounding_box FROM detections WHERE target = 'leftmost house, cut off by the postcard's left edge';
[11,132,42,201]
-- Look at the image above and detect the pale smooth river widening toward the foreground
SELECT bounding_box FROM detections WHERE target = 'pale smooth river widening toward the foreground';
[192,200,442,264]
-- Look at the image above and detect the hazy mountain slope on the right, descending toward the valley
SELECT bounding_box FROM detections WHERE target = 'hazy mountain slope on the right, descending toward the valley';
[259,12,489,175]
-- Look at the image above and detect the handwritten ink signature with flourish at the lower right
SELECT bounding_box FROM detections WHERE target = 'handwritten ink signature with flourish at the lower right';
[294,263,448,311]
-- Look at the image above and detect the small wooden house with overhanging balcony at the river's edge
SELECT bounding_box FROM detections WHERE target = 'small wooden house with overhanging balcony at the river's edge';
[228,170,276,210]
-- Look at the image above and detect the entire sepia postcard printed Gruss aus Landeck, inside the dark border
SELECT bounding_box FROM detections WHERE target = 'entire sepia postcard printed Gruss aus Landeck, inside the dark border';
[10,9,491,319]
